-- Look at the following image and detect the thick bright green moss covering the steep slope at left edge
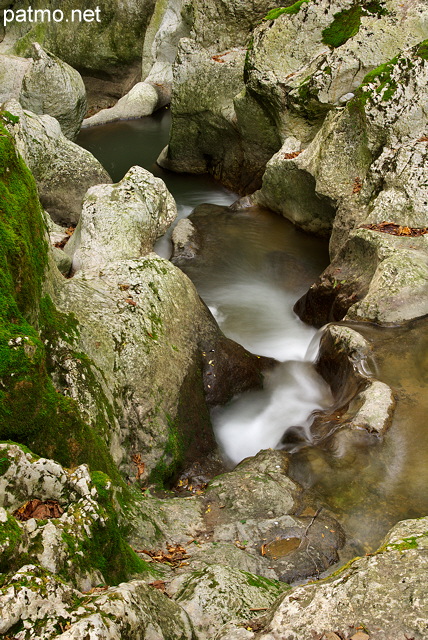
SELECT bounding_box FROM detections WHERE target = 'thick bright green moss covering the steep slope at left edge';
[0,124,120,482]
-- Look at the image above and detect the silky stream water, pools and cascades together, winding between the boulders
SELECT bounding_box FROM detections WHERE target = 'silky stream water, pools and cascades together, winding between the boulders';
[78,110,428,555]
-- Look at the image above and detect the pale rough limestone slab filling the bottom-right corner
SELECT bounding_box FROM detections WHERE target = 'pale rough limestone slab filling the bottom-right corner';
[218,518,428,640]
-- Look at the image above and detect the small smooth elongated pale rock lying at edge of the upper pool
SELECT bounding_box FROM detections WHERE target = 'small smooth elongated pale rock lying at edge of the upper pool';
[83,82,159,127]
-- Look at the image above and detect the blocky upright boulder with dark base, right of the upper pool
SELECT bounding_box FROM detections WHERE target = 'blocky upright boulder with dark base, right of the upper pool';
[158,38,280,192]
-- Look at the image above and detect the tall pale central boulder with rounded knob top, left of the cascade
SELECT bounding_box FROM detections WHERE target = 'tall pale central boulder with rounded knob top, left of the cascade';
[52,167,270,482]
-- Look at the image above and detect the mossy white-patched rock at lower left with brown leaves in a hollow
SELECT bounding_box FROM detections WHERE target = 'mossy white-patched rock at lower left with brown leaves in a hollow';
[0,443,154,590]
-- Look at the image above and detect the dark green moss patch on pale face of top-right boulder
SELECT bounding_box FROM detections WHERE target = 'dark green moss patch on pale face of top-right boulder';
[322,2,387,48]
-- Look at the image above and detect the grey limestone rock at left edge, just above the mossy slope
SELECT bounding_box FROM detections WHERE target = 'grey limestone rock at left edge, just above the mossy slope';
[4,100,111,225]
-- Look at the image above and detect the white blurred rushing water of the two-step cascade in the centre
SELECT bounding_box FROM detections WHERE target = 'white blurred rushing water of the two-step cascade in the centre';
[209,281,332,464]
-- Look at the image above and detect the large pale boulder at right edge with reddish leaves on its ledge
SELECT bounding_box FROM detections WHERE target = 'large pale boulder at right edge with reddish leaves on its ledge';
[292,45,428,325]
